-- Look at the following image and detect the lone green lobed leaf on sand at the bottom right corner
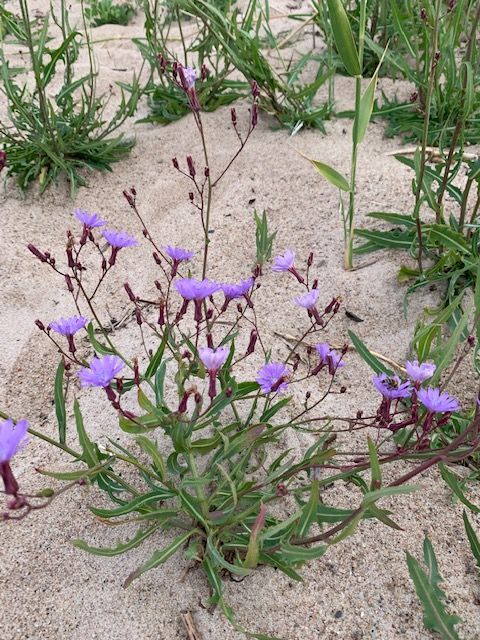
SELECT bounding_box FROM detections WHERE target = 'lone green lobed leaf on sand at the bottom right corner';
[407,553,460,640]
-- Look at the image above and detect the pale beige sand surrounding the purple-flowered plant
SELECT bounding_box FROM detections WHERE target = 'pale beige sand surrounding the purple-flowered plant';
[0,2,480,640]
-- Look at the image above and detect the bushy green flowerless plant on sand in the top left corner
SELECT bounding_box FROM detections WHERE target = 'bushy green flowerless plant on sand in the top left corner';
[0,0,140,196]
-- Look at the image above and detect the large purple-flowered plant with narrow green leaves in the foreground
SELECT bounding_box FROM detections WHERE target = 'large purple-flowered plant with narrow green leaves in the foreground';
[0,62,480,639]
